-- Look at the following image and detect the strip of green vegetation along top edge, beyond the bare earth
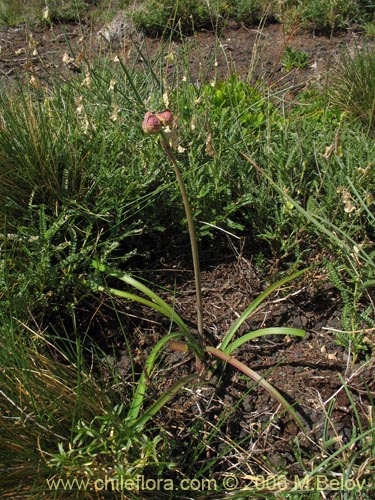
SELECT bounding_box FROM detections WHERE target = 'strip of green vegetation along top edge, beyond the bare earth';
[0,0,374,29]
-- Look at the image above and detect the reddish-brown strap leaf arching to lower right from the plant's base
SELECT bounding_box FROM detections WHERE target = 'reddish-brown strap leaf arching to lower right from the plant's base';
[206,347,304,431]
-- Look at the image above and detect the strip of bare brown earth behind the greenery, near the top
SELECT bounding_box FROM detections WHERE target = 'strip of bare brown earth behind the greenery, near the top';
[0,20,360,91]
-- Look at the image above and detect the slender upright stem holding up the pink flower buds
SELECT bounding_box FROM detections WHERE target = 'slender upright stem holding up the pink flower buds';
[160,133,204,346]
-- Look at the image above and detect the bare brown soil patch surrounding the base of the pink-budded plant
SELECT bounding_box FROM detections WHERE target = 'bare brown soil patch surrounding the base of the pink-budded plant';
[93,251,375,490]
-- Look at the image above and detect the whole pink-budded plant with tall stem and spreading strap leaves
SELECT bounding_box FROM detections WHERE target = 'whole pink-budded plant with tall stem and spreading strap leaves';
[93,109,306,429]
